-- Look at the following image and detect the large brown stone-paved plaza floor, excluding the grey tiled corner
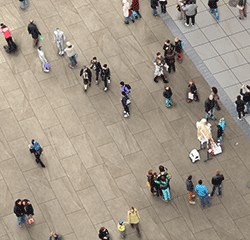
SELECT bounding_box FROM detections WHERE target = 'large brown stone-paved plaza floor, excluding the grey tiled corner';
[0,0,250,240]
